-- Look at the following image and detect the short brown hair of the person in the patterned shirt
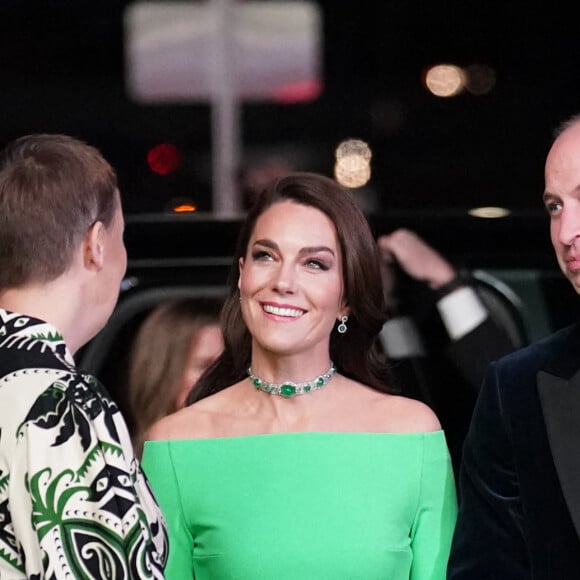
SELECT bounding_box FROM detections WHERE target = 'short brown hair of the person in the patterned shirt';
[0,134,118,289]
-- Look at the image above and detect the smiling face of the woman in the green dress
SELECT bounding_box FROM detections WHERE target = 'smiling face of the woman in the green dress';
[238,201,347,357]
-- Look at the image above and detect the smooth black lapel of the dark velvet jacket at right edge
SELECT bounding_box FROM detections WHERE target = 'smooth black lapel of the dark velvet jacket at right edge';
[537,325,580,538]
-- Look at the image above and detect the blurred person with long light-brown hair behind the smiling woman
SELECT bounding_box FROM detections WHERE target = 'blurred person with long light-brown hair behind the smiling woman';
[127,297,223,456]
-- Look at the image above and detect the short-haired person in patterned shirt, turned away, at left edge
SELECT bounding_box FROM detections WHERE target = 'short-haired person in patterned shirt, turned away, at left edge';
[0,134,167,580]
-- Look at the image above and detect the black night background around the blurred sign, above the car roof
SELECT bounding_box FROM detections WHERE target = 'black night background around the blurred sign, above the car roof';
[0,0,580,214]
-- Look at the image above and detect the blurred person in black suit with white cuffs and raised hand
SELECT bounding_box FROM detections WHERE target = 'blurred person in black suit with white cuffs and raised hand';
[378,228,520,475]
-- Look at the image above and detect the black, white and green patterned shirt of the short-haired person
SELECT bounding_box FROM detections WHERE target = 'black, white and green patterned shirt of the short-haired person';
[0,309,167,580]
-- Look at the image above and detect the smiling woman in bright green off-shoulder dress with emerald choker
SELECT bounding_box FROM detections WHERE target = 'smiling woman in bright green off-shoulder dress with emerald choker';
[143,173,457,580]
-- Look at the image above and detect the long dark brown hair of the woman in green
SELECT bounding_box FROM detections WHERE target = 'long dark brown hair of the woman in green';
[193,173,392,403]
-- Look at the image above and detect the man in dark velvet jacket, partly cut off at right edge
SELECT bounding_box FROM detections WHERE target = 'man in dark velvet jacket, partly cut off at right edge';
[448,115,580,580]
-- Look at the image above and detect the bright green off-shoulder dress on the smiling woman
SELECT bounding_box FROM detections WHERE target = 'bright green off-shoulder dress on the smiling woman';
[143,431,457,580]
